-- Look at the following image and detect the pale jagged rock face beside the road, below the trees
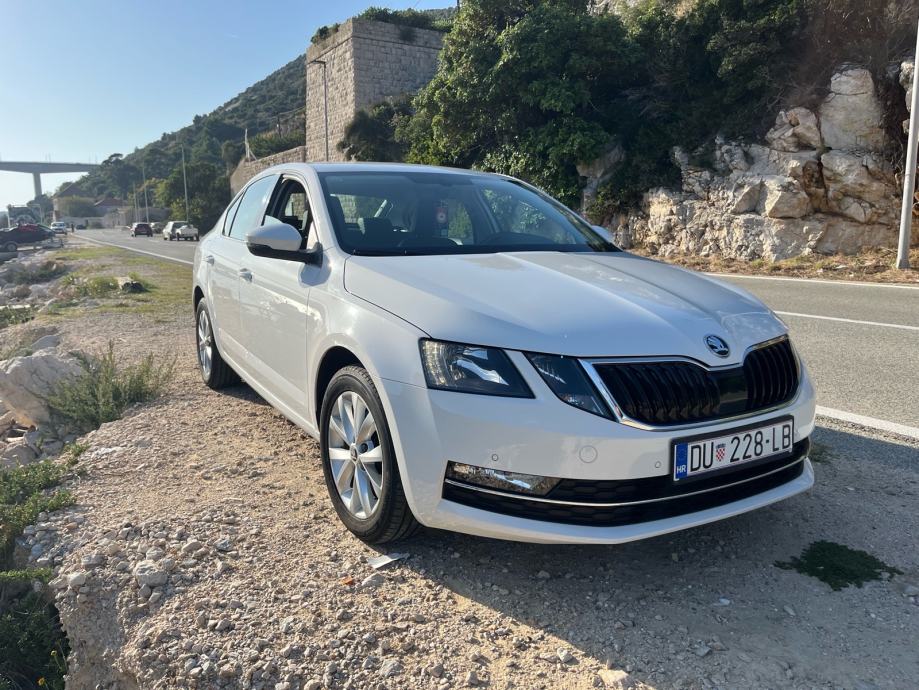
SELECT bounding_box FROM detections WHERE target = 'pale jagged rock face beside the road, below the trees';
[619,62,912,261]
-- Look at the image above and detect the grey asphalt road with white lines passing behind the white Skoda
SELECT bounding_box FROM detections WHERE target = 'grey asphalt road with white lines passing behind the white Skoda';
[79,230,919,438]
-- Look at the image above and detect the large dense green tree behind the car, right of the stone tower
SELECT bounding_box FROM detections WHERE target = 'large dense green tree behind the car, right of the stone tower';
[399,0,640,202]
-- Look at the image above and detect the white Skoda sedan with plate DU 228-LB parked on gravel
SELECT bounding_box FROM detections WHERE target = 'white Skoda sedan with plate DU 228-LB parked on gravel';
[194,164,815,544]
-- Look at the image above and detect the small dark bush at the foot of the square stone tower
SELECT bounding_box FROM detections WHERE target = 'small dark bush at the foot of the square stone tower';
[336,96,412,162]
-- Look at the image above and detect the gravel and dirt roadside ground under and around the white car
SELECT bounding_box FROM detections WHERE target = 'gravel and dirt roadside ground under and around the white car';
[12,250,919,690]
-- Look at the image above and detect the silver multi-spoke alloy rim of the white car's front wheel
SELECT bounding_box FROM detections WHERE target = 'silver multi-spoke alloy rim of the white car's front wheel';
[326,391,383,520]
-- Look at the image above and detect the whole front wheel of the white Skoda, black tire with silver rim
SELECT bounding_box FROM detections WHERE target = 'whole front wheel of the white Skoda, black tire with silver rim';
[319,366,418,544]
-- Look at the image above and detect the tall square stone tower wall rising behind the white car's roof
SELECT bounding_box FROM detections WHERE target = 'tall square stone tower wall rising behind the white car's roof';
[306,19,443,161]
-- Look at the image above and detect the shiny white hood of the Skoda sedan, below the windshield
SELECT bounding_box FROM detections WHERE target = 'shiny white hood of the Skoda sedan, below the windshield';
[345,252,785,366]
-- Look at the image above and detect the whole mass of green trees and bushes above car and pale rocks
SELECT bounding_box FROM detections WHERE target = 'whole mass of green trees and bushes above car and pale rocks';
[340,0,916,221]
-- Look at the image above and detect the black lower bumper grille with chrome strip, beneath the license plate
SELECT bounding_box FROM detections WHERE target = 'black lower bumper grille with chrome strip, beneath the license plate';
[443,439,810,527]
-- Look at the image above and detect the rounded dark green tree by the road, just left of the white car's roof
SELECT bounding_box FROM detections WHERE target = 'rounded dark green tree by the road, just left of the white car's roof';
[156,161,230,232]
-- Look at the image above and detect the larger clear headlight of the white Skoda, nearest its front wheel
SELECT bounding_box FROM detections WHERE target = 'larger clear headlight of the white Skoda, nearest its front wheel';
[421,340,533,398]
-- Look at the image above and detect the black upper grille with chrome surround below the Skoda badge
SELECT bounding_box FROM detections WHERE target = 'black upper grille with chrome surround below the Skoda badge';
[593,338,798,425]
